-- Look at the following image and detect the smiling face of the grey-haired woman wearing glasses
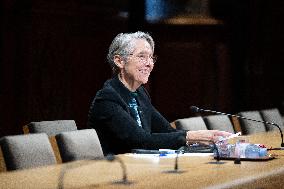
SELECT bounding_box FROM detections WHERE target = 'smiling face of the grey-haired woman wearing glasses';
[121,39,154,85]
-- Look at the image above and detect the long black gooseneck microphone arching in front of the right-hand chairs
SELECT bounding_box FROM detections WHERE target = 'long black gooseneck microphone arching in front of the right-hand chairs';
[190,106,284,149]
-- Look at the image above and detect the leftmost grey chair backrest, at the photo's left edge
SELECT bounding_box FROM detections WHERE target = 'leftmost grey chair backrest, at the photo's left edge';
[1,133,56,170]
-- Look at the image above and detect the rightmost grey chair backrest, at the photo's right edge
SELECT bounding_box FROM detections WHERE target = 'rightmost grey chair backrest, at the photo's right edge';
[260,108,284,131]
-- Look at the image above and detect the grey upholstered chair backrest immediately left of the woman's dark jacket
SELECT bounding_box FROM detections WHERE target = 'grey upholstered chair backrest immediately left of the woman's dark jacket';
[56,129,103,162]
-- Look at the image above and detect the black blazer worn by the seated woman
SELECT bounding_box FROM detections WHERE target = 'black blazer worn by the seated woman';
[88,76,186,155]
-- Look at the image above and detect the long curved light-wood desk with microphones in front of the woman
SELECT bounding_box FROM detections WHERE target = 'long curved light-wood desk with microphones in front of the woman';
[0,133,284,189]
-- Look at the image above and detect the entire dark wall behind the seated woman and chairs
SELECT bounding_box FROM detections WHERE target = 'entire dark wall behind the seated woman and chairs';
[0,0,284,136]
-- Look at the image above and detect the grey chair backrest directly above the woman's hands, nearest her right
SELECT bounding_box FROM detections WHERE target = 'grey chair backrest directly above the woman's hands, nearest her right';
[175,116,207,131]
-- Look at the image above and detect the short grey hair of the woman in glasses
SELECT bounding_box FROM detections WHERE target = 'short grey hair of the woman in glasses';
[107,31,155,74]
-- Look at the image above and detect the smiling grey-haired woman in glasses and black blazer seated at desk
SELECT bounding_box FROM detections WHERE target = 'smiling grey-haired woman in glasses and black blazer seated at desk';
[88,31,231,154]
